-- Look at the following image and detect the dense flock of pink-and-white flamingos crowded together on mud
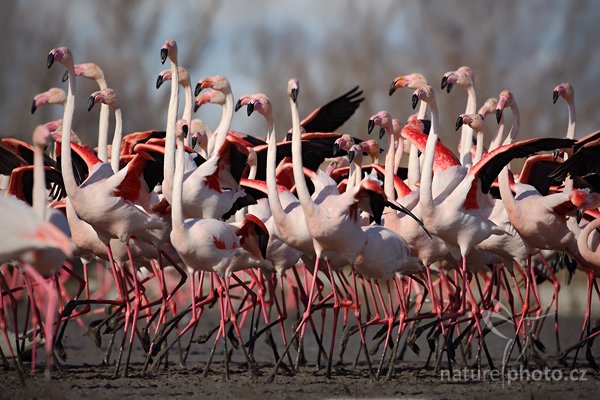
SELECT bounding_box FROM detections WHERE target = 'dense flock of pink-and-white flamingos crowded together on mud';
[0,40,600,380]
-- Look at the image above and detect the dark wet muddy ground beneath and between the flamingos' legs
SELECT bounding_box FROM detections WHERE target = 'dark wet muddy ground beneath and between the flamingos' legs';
[0,276,600,400]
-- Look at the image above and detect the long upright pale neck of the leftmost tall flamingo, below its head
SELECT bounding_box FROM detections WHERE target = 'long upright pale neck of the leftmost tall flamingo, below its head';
[60,65,79,198]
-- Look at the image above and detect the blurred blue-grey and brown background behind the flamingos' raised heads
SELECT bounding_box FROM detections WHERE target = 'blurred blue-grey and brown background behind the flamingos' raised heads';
[0,0,600,155]
